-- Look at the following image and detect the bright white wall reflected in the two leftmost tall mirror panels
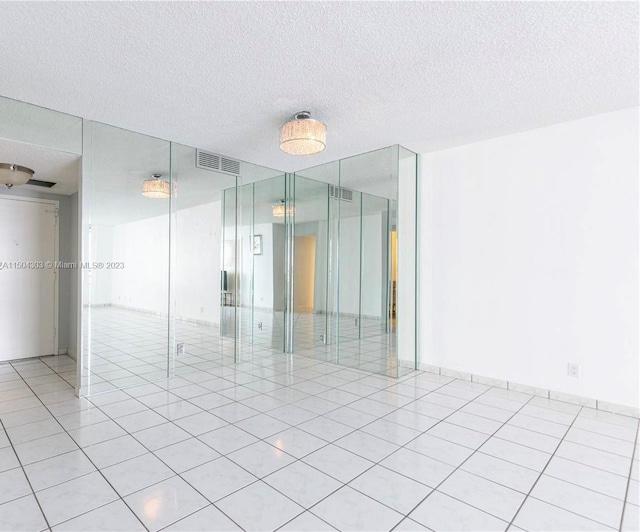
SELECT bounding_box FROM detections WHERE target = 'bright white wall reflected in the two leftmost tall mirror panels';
[91,201,222,324]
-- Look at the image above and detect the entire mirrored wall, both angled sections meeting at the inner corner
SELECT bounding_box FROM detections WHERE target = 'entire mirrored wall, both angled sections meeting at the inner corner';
[82,121,416,394]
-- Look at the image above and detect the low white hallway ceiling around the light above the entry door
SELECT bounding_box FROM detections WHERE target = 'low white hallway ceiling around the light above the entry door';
[0,139,80,196]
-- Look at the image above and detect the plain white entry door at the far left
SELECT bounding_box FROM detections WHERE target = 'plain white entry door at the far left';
[0,198,58,361]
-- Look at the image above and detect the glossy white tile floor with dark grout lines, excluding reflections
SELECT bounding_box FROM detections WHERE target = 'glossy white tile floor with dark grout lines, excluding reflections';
[0,350,640,531]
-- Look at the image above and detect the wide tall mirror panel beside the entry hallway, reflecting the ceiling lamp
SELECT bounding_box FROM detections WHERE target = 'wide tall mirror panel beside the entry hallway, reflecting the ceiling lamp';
[82,122,171,393]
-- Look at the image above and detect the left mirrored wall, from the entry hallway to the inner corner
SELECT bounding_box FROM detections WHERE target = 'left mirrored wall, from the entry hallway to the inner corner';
[82,122,284,395]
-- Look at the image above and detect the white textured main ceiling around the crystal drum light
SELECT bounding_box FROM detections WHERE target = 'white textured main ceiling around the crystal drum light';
[0,2,638,170]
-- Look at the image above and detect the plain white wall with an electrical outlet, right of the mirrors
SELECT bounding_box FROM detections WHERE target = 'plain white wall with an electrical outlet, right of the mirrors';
[420,108,639,407]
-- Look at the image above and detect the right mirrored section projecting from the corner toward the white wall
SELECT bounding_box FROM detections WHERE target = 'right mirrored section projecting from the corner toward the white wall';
[289,146,417,376]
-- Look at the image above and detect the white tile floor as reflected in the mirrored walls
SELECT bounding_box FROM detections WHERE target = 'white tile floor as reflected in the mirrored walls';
[87,306,397,394]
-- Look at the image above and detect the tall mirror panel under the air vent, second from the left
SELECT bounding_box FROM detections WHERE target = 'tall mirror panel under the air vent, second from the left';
[171,144,236,375]
